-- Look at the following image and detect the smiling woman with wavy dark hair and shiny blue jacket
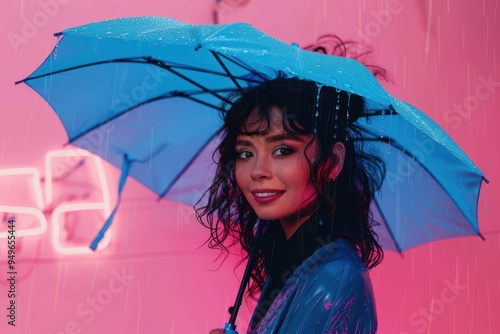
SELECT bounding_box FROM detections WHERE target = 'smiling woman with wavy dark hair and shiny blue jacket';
[197,78,385,333]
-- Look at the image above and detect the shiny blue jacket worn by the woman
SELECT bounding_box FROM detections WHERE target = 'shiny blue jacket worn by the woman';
[248,239,377,334]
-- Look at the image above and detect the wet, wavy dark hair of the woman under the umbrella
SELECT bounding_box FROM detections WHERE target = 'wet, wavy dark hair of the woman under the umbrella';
[196,78,385,296]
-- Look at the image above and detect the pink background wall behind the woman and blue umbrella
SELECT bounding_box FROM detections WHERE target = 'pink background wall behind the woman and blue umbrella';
[0,0,500,334]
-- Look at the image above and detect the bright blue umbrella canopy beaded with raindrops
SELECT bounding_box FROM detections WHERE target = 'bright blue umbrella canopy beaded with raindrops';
[17,17,484,251]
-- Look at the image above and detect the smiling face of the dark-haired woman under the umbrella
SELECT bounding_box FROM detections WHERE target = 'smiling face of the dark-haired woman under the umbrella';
[235,107,319,224]
